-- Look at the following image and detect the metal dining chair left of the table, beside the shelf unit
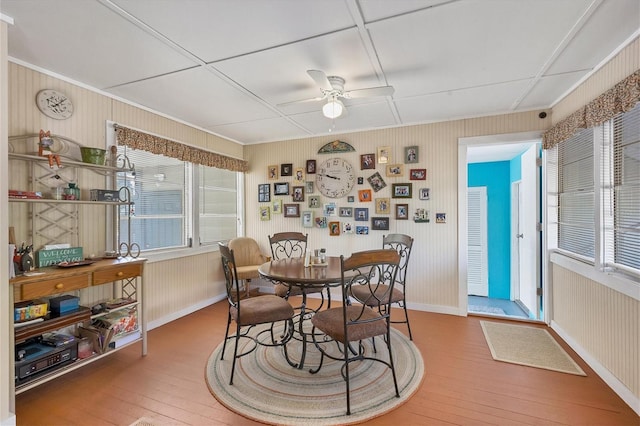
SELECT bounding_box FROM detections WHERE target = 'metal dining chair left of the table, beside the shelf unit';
[218,243,294,385]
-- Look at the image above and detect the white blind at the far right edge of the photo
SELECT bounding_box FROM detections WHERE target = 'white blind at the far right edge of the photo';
[604,103,640,271]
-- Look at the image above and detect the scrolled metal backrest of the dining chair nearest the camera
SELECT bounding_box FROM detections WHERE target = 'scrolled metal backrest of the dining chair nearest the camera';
[340,249,400,323]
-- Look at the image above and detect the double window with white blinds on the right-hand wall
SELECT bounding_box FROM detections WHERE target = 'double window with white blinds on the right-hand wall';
[547,103,640,277]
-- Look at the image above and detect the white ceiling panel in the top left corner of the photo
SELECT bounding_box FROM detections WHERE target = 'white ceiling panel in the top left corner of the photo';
[2,0,194,89]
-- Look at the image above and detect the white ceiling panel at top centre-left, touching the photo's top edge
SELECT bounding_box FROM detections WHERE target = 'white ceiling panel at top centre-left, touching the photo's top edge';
[114,0,355,62]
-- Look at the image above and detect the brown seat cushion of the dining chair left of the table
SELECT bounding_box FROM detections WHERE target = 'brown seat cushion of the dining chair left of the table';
[229,294,293,325]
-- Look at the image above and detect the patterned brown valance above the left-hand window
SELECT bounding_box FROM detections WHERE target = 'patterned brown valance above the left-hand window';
[114,124,249,172]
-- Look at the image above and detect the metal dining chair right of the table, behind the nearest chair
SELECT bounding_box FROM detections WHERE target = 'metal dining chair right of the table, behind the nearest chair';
[353,234,413,340]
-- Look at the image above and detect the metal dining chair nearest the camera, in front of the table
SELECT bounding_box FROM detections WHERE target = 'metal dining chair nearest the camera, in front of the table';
[310,249,400,415]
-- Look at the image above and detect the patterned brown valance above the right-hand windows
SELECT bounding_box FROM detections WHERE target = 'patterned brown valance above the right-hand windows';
[542,70,640,149]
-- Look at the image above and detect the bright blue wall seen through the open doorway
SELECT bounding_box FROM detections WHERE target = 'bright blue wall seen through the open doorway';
[467,161,510,299]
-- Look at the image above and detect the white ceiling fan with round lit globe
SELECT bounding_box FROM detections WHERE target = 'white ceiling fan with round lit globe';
[278,70,394,118]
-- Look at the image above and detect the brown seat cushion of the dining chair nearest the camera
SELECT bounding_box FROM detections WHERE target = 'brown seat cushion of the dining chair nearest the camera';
[311,305,387,343]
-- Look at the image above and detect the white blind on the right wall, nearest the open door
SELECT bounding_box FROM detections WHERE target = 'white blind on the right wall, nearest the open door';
[557,129,595,260]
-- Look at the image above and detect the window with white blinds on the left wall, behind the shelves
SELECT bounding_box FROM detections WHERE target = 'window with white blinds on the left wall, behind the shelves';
[118,146,238,252]
